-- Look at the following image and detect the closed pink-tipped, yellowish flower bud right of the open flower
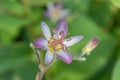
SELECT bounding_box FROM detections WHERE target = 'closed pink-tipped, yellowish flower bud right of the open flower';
[82,38,99,55]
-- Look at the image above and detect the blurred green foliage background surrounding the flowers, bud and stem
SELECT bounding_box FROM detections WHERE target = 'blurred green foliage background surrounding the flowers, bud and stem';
[0,0,120,80]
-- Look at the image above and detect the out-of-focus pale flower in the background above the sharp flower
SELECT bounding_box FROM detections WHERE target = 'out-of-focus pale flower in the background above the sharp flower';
[45,2,70,22]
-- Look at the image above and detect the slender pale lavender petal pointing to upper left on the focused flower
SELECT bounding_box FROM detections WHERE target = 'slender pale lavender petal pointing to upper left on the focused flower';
[41,22,51,39]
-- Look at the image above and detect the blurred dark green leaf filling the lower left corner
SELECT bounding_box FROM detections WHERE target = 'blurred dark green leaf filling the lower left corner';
[0,44,38,80]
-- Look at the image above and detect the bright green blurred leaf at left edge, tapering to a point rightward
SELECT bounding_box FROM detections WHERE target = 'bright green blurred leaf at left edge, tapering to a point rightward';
[0,14,29,43]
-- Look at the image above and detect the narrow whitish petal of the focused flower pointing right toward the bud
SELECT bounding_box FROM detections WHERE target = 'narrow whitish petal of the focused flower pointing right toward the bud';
[63,36,83,47]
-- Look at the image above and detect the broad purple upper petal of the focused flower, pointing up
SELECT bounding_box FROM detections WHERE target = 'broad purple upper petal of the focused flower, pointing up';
[54,21,68,38]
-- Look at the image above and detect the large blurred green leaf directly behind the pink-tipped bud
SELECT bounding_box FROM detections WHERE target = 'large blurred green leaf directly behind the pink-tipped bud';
[48,14,115,80]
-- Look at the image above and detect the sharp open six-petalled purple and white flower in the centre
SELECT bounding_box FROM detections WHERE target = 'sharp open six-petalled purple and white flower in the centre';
[34,21,83,64]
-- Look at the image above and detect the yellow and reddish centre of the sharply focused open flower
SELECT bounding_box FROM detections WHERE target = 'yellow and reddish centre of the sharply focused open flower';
[48,38,65,53]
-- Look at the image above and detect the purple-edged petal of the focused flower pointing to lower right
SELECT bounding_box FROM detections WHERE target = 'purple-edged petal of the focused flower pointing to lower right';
[55,50,72,64]
